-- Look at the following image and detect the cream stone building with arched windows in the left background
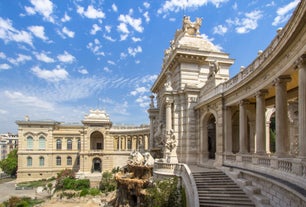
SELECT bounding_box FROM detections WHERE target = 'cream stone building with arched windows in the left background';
[16,110,149,182]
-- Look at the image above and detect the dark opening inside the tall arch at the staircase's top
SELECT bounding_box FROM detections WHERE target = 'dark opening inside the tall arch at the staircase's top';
[207,114,216,159]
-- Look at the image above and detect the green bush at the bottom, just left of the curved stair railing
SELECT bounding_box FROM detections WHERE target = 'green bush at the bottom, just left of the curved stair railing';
[145,177,186,207]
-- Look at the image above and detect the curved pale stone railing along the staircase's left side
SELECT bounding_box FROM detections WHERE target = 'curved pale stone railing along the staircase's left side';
[153,162,199,207]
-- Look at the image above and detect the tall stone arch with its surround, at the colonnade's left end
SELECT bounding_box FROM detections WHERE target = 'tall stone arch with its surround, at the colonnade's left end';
[199,110,217,164]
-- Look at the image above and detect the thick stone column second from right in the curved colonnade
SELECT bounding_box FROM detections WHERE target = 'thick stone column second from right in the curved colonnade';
[274,75,291,157]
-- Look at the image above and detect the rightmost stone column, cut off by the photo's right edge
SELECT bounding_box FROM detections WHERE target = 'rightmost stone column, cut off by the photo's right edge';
[297,54,306,159]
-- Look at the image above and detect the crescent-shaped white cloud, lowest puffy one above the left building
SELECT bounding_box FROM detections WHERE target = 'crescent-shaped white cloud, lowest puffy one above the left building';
[31,66,68,82]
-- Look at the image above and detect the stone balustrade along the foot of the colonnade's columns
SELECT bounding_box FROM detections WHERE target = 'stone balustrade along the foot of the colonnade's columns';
[223,154,306,188]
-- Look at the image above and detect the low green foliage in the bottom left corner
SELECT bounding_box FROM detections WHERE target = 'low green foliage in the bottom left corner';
[0,196,44,207]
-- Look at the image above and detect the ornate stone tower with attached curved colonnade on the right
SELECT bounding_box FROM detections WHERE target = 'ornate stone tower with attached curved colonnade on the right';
[148,1,306,205]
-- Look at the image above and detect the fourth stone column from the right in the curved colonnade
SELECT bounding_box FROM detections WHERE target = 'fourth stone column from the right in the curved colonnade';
[239,100,249,154]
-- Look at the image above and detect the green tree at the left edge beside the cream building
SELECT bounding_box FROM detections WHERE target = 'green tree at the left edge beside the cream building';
[0,149,18,176]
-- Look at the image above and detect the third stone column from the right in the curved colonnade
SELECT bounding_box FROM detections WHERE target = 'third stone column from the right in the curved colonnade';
[256,90,268,154]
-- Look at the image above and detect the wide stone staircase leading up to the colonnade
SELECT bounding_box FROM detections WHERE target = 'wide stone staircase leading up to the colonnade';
[192,170,255,207]
